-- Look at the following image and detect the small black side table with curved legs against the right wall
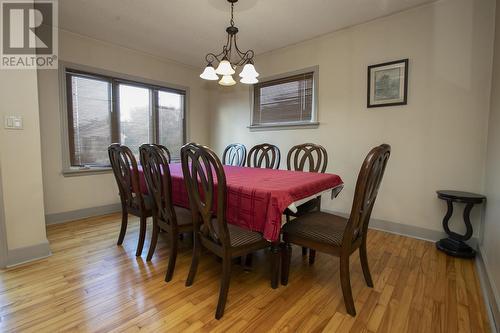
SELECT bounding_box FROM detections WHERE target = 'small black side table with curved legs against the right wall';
[436,191,486,258]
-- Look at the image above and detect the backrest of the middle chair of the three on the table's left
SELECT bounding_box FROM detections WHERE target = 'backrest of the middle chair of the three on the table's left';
[139,144,175,223]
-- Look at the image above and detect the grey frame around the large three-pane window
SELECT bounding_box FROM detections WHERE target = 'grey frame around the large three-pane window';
[59,61,189,177]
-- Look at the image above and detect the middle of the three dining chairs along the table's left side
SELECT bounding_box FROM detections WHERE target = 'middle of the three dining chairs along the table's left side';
[139,144,193,282]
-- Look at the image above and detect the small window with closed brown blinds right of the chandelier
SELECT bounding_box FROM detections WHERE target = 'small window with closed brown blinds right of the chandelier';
[251,70,317,127]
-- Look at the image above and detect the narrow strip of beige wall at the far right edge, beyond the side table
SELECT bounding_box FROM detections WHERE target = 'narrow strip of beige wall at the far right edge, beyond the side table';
[481,0,500,314]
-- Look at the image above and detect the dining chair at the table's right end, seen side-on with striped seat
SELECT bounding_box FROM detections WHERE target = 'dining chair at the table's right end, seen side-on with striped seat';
[281,144,391,316]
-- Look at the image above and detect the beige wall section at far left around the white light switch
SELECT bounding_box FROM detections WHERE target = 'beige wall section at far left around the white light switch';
[0,70,48,255]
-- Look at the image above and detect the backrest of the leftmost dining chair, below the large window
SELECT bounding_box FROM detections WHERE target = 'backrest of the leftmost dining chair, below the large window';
[108,143,146,211]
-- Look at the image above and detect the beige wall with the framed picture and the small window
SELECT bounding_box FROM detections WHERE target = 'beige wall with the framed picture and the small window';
[211,0,495,231]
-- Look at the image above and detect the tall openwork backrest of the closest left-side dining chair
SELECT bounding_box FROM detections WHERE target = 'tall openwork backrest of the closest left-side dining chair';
[181,143,231,247]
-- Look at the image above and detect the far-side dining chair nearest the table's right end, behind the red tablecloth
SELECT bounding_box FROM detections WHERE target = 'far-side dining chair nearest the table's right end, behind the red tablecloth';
[285,143,328,264]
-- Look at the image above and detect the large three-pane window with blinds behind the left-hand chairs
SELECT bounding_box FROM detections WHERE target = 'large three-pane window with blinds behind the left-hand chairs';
[65,68,186,167]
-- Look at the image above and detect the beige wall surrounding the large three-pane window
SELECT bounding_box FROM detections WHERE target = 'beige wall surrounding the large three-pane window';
[39,31,209,214]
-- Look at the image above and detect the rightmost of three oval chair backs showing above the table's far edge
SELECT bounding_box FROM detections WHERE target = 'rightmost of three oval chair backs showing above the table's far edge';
[286,143,328,173]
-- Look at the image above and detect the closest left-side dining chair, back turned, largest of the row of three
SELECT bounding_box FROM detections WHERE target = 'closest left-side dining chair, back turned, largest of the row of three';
[181,143,280,319]
